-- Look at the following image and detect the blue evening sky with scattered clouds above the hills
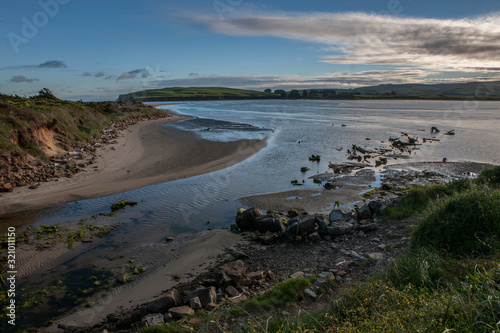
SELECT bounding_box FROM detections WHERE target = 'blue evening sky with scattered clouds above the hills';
[0,0,500,101]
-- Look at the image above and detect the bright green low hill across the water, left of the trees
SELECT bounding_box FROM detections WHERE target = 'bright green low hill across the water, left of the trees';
[118,87,276,102]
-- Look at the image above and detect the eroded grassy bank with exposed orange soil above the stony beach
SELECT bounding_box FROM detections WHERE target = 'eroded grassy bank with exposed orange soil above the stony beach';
[0,89,169,172]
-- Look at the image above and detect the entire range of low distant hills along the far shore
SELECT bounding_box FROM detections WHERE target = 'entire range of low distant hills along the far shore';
[118,81,500,102]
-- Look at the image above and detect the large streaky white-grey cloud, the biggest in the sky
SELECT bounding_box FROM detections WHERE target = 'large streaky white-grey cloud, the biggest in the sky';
[192,13,500,71]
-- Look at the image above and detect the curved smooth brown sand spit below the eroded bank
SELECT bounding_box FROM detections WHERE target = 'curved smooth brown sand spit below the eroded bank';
[0,115,267,215]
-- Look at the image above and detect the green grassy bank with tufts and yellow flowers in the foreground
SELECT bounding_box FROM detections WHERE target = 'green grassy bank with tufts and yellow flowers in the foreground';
[140,167,500,332]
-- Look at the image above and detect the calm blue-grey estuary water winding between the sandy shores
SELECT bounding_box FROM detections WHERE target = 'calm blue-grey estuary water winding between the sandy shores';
[3,100,500,246]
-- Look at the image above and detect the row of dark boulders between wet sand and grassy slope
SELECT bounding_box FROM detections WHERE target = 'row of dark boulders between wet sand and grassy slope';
[231,199,396,245]
